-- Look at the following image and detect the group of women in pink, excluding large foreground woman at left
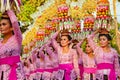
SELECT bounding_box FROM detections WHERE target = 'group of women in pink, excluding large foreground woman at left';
[21,28,120,80]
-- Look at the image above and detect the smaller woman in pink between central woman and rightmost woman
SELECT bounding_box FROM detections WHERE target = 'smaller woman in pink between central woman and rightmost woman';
[77,40,97,80]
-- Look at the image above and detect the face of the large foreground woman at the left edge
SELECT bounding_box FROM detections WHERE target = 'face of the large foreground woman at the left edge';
[0,19,13,34]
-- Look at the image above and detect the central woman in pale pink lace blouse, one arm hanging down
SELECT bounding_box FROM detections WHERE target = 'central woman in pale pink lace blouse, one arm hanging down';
[52,32,80,80]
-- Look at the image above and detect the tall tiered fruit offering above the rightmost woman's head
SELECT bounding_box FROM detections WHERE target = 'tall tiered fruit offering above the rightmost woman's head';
[95,0,112,29]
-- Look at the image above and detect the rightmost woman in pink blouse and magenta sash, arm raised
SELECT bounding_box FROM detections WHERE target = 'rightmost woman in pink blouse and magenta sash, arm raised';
[88,29,120,80]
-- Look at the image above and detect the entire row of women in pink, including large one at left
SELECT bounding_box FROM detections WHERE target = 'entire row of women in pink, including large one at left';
[0,10,120,80]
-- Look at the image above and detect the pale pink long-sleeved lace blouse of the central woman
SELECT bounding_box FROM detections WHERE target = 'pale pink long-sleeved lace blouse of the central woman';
[51,32,80,77]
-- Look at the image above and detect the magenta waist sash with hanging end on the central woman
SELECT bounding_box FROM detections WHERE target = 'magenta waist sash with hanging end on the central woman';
[59,63,73,80]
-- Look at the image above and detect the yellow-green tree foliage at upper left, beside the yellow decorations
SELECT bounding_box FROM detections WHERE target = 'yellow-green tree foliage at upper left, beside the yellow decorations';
[17,0,47,32]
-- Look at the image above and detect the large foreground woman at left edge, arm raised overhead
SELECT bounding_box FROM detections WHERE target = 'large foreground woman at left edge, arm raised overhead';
[0,10,24,80]
